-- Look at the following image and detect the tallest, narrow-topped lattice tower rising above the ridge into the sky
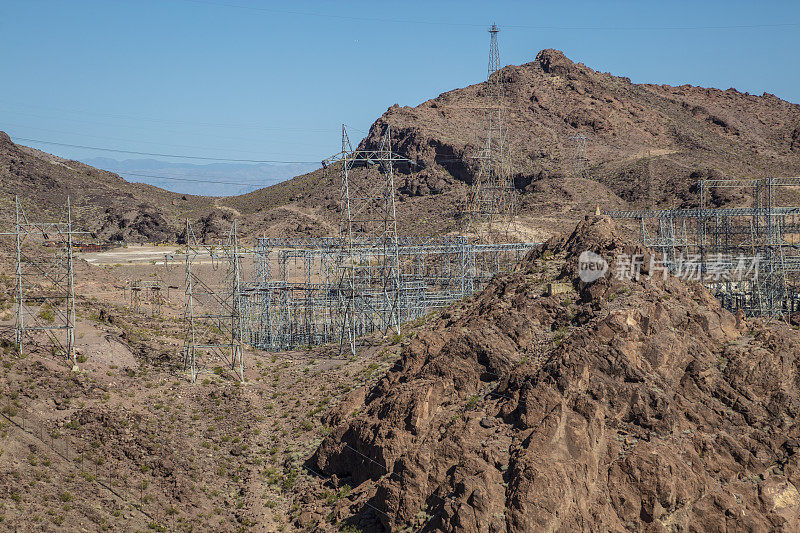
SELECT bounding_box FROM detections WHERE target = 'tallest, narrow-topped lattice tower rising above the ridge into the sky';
[465,24,517,240]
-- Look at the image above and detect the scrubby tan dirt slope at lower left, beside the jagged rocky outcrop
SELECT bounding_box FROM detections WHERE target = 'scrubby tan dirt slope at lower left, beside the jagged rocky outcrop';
[0,257,399,533]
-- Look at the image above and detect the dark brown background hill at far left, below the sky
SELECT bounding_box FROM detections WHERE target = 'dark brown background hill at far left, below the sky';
[0,132,232,242]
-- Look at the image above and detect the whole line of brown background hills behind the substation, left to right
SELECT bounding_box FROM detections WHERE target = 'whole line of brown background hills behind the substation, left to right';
[0,50,800,240]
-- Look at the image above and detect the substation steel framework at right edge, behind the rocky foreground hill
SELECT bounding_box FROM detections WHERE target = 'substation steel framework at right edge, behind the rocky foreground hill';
[605,178,800,319]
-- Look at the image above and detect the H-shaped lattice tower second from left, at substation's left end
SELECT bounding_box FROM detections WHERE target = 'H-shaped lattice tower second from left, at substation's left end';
[183,219,245,382]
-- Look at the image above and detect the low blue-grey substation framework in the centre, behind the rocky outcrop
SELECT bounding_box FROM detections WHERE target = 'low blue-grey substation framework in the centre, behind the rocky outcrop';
[243,237,539,351]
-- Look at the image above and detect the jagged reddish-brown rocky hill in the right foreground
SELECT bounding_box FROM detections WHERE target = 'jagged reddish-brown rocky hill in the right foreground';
[305,217,800,532]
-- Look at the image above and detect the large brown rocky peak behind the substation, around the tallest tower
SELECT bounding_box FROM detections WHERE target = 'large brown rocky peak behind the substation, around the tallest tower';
[222,50,800,240]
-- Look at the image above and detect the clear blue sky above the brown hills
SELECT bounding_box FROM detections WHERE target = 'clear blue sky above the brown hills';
[0,0,800,165]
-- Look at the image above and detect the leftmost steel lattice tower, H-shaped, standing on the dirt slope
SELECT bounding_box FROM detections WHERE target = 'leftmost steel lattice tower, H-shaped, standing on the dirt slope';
[3,197,85,369]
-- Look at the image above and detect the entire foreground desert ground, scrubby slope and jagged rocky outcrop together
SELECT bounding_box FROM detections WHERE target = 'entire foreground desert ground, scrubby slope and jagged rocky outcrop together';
[0,217,800,532]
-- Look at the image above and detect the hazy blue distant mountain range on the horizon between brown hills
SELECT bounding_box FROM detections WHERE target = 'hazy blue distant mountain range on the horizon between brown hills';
[85,157,319,196]
